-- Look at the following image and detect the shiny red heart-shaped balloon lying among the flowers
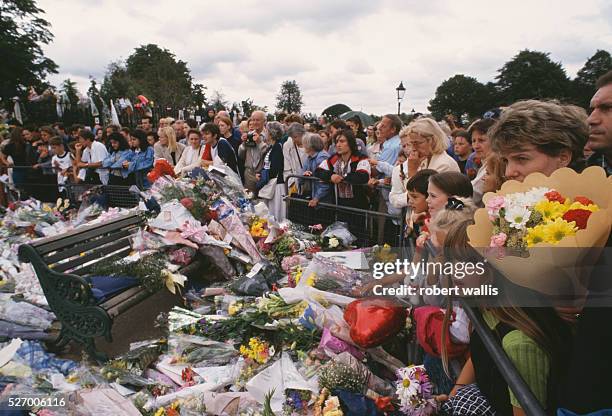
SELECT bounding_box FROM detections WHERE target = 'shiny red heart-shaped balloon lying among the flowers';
[344,298,407,348]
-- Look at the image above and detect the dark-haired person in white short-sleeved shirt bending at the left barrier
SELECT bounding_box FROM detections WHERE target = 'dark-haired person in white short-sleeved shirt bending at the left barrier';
[75,129,108,185]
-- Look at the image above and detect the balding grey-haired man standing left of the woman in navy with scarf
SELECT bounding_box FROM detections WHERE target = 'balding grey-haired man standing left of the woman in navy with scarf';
[238,110,268,192]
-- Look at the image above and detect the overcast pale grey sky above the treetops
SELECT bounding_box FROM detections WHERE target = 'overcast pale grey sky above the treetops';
[38,0,612,114]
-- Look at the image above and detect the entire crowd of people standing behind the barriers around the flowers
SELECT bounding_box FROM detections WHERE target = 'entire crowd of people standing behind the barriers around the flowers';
[0,72,612,415]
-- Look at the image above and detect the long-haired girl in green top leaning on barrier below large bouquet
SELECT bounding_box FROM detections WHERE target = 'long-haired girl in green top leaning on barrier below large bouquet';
[442,219,571,416]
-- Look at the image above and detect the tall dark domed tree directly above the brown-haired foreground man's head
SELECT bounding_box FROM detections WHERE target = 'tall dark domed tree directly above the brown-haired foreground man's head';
[496,49,570,104]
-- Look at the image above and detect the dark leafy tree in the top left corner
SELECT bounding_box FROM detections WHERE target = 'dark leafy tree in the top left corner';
[0,0,57,109]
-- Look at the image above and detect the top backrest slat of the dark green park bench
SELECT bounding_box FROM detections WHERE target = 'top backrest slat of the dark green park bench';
[30,215,142,255]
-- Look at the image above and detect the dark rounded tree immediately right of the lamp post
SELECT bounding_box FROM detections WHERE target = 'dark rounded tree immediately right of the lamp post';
[428,74,495,119]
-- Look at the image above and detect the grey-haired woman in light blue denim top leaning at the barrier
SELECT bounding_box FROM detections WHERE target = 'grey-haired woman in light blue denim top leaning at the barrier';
[300,133,332,207]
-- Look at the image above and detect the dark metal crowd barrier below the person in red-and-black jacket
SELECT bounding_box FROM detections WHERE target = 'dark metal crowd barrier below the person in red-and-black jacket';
[285,175,404,247]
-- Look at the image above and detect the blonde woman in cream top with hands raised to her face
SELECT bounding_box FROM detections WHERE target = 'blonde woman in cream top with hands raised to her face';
[389,118,461,208]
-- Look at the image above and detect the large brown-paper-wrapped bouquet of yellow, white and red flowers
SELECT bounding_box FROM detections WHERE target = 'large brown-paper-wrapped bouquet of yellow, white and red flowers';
[467,167,612,296]
